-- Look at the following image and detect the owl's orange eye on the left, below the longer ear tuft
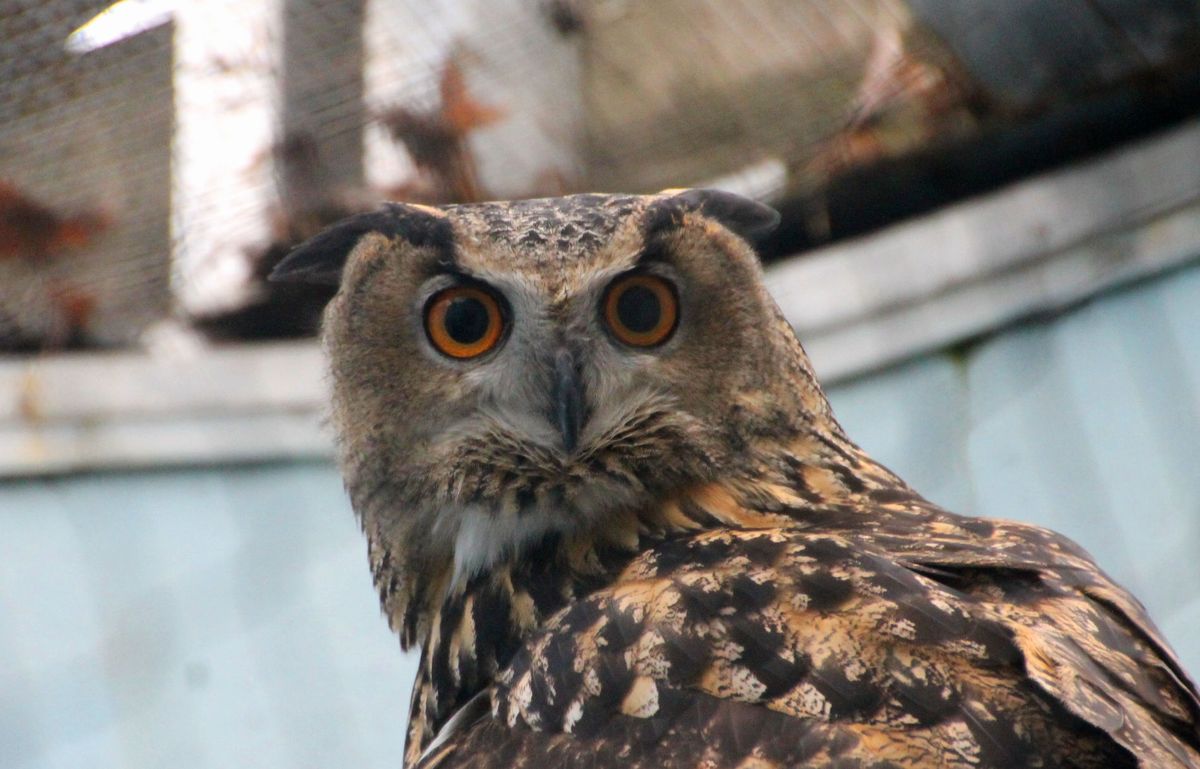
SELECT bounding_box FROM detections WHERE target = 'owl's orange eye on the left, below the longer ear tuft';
[425,286,504,360]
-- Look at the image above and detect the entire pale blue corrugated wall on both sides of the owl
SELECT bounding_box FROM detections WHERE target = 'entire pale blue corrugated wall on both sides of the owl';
[0,259,1200,769]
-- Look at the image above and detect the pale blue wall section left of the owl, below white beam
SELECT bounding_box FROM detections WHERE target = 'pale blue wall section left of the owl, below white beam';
[0,464,408,769]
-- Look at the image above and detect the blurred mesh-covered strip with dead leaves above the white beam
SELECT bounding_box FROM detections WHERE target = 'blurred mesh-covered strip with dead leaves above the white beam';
[0,0,1200,350]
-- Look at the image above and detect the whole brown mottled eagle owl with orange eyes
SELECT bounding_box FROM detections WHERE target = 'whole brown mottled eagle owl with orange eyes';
[275,190,1200,769]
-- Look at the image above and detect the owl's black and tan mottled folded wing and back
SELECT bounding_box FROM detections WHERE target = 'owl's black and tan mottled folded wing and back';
[422,515,1198,767]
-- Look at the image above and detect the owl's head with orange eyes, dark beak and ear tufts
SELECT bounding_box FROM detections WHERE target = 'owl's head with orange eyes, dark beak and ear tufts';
[274,190,827,576]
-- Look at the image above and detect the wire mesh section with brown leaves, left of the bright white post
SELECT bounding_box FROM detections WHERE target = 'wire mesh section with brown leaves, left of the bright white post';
[0,1,173,347]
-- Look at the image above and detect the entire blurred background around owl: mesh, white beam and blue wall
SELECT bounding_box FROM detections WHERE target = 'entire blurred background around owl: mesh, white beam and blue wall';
[0,0,1200,769]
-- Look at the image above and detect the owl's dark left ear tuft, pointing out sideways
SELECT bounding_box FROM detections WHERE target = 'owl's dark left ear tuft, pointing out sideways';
[268,203,454,286]
